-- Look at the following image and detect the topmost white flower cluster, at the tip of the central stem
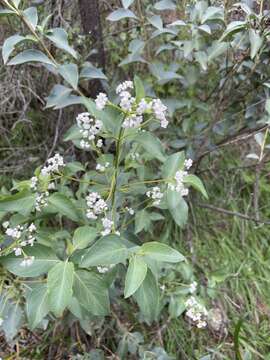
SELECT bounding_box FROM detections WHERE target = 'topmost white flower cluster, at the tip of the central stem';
[95,80,169,129]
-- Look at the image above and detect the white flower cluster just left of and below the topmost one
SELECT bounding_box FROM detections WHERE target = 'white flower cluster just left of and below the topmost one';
[76,112,103,149]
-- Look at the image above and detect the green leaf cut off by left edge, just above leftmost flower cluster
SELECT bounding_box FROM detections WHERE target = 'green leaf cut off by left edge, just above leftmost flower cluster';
[0,191,35,215]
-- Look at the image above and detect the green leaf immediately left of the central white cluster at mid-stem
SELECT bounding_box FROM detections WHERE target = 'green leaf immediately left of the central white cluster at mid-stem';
[48,193,79,222]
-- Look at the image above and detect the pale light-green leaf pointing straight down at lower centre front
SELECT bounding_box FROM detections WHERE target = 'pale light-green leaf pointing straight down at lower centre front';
[124,255,147,298]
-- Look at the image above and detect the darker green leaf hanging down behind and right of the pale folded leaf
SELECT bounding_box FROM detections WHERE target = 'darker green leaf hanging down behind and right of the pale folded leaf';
[134,269,159,324]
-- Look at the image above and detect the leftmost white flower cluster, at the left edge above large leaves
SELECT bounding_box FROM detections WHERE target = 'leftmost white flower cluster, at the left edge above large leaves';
[2,221,36,262]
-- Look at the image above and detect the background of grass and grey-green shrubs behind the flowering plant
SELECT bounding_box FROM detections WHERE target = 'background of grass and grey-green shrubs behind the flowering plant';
[0,0,270,360]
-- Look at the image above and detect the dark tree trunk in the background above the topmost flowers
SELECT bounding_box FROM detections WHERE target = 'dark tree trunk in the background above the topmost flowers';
[79,0,105,98]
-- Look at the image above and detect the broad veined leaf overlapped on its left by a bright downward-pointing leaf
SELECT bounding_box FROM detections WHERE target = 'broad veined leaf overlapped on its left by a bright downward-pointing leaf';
[74,270,110,316]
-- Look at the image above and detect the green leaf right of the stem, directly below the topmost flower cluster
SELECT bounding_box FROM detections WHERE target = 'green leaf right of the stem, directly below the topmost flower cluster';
[134,131,166,162]
